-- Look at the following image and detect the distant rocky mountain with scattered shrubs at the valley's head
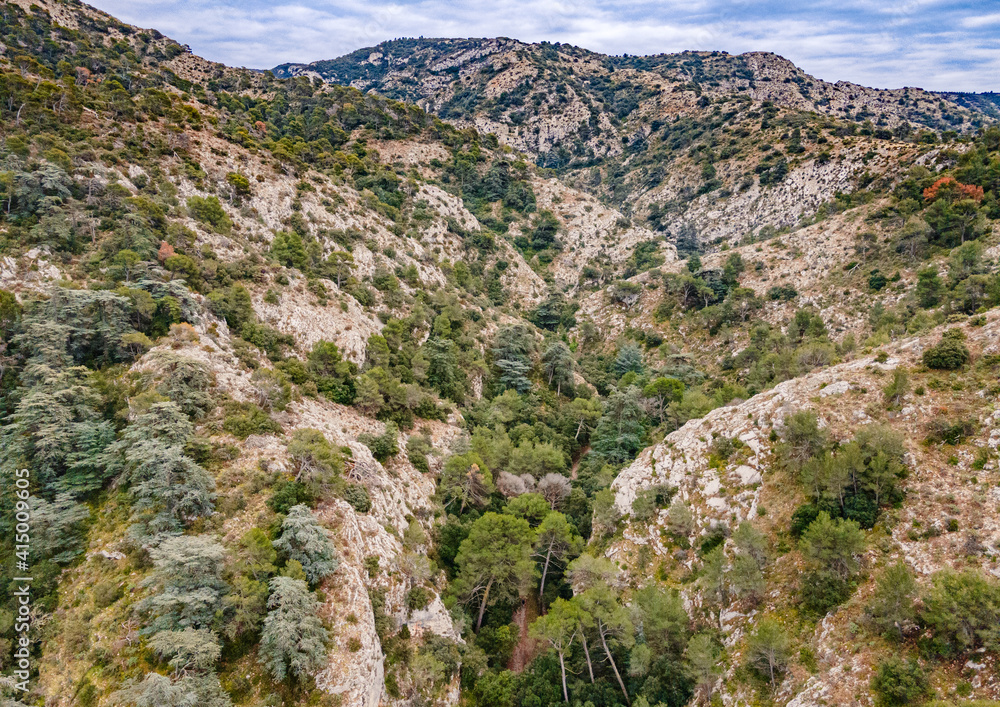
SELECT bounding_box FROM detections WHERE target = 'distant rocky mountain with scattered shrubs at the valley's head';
[274,38,996,248]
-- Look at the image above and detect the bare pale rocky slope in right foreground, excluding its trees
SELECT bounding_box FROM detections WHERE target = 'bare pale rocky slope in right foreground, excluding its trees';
[606,313,1000,705]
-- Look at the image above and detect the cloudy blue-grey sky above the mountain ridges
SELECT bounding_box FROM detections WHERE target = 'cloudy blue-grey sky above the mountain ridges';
[89,0,1000,91]
